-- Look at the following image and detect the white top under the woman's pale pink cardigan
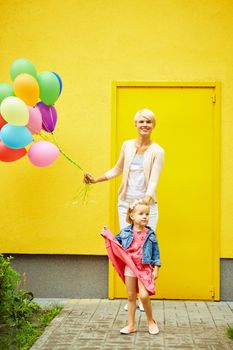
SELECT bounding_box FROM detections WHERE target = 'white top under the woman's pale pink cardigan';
[126,154,146,201]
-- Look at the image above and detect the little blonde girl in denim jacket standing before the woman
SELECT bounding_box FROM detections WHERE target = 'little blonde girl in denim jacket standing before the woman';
[116,199,160,334]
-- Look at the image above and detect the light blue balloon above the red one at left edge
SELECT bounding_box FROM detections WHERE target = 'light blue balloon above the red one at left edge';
[1,124,33,149]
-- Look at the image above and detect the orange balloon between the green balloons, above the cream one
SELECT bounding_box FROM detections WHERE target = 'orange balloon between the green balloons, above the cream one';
[13,73,40,106]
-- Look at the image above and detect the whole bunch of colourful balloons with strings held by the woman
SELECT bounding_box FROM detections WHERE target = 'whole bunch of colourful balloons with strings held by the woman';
[0,58,90,202]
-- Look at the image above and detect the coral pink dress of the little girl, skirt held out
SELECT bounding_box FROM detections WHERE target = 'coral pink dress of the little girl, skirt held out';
[101,228,155,295]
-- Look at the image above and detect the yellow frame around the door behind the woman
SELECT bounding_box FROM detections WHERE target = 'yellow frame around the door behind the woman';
[108,81,221,300]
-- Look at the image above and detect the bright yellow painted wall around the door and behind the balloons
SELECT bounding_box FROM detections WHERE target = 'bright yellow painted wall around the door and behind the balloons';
[0,0,233,258]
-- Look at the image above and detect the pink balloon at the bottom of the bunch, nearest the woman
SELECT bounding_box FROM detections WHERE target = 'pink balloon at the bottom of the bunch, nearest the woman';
[28,141,60,167]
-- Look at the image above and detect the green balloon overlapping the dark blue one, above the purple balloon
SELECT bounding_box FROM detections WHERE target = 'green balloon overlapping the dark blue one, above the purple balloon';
[37,71,60,106]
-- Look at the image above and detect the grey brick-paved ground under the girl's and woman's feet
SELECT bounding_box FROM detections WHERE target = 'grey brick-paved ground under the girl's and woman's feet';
[31,299,233,350]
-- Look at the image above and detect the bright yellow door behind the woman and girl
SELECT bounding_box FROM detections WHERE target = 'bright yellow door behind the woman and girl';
[109,83,219,300]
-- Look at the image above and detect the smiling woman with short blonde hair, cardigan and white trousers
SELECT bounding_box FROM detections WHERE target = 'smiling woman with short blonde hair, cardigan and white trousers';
[84,109,164,311]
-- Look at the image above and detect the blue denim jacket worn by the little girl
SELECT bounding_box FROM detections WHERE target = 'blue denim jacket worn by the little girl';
[116,225,161,266]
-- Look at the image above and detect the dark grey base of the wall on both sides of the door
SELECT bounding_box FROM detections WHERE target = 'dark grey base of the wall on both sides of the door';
[6,254,233,301]
